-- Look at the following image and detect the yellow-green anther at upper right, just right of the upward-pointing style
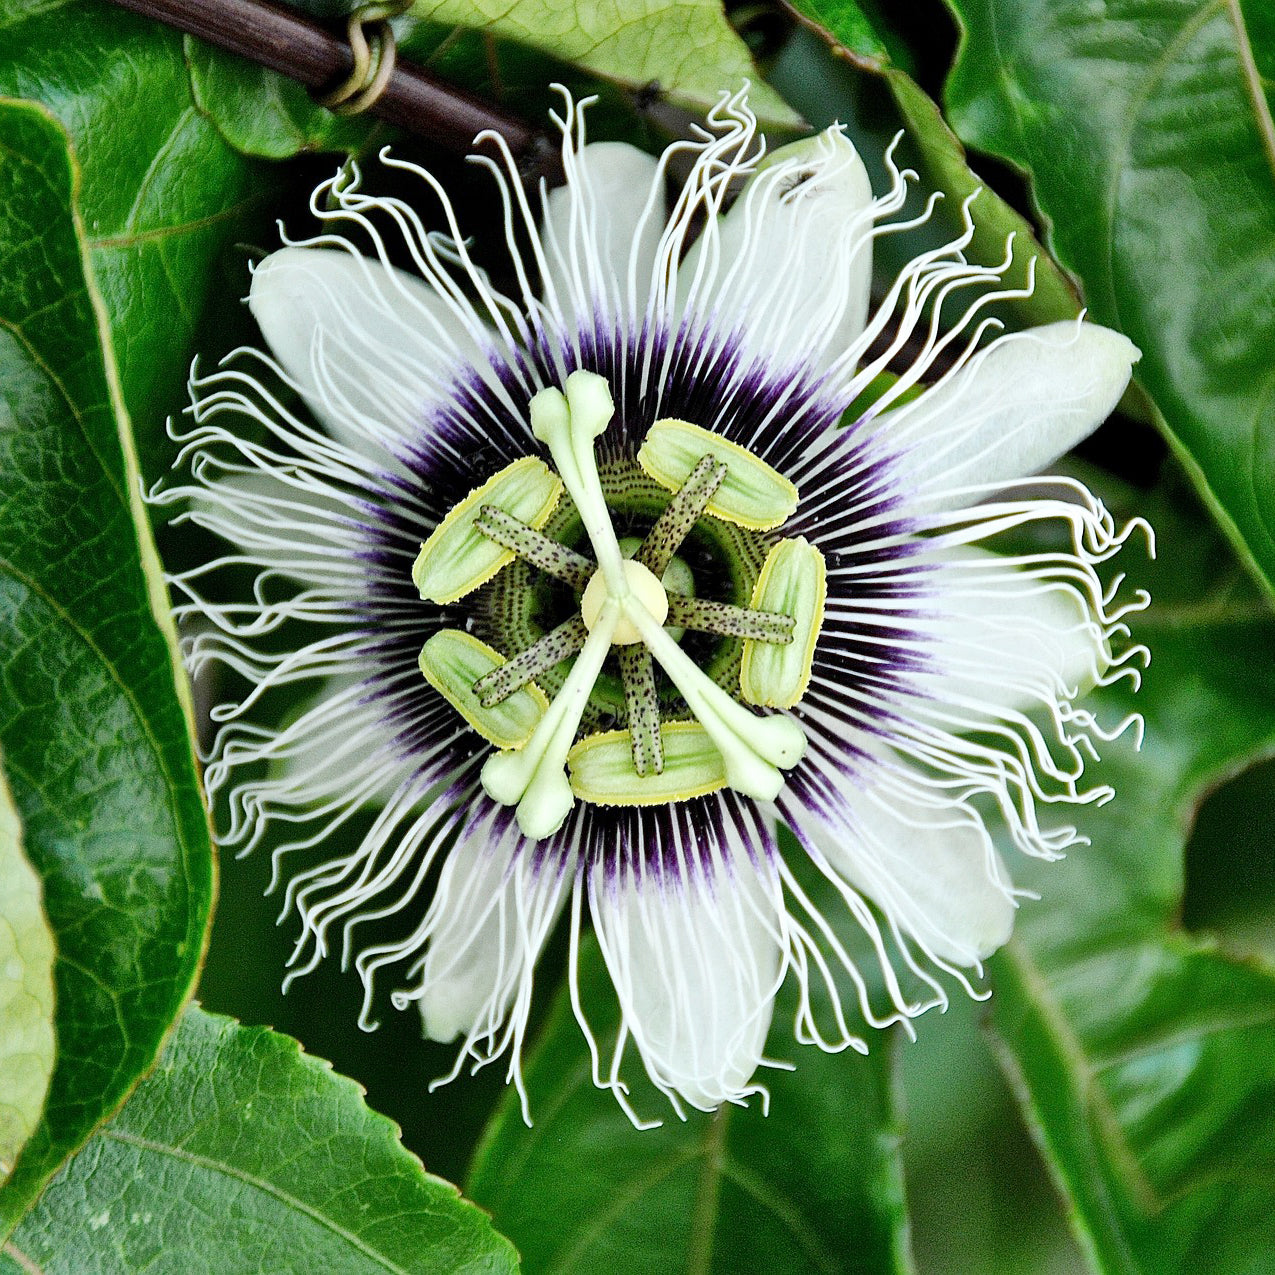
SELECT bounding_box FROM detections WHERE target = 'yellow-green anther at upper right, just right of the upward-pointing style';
[638,417,797,532]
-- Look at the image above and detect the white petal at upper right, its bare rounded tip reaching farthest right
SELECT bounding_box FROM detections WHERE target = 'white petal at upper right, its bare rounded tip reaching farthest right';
[877,321,1141,509]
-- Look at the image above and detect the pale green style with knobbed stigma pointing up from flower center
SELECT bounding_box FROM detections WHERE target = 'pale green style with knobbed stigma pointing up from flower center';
[530,371,629,598]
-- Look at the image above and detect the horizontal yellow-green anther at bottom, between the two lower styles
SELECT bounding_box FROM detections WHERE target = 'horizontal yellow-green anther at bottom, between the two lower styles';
[566,722,727,806]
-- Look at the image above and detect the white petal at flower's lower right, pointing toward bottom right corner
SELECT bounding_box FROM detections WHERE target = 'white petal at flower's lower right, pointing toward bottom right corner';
[793,764,1015,966]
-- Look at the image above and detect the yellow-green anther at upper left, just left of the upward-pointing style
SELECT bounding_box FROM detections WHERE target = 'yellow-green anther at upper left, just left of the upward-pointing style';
[412,456,562,604]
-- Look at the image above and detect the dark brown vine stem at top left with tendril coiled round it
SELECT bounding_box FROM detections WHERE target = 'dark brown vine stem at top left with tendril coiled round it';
[113,0,557,181]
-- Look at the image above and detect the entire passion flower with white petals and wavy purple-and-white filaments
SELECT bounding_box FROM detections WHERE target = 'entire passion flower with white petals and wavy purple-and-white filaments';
[153,96,1145,1121]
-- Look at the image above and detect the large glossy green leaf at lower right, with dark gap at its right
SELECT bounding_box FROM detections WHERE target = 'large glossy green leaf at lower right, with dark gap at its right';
[991,471,1275,1275]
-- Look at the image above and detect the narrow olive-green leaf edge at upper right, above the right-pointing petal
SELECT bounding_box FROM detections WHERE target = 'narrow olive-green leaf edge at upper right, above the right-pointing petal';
[792,0,1080,326]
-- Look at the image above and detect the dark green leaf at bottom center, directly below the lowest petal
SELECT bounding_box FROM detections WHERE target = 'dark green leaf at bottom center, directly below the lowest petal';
[468,938,910,1275]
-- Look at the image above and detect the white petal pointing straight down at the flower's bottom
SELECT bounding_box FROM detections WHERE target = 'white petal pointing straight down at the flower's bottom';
[590,862,782,1111]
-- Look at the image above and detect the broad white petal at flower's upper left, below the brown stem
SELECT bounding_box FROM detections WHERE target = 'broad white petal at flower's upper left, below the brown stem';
[249,247,478,455]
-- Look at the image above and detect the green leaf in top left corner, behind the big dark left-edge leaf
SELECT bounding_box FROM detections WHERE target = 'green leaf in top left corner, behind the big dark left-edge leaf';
[0,0,266,438]
